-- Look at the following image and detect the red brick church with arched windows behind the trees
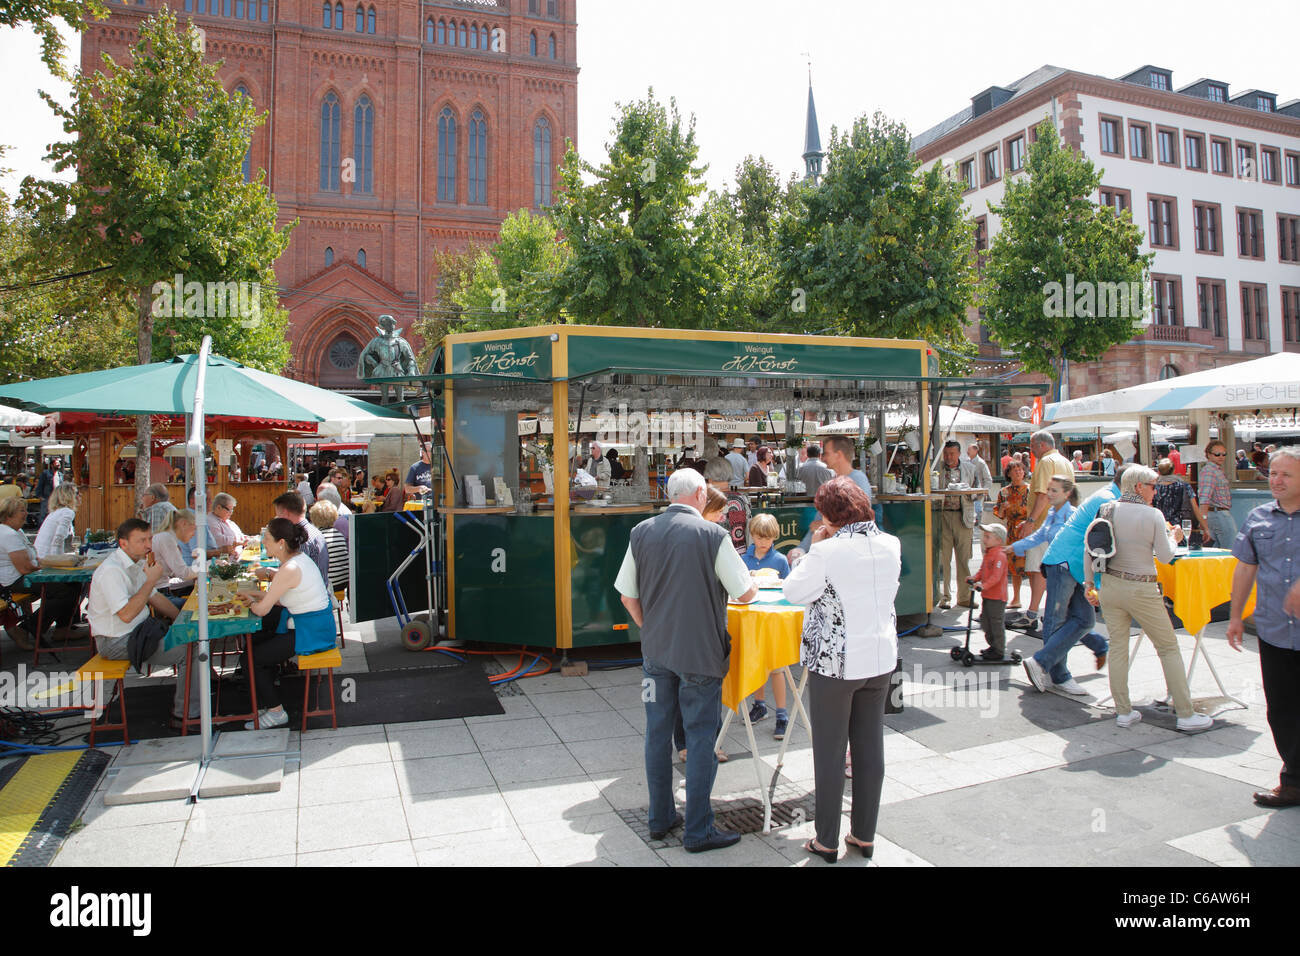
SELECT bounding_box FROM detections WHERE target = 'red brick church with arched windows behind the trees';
[82,0,579,389]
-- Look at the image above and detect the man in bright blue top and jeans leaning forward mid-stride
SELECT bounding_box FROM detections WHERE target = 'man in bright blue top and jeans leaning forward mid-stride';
[1024,464,1128,692]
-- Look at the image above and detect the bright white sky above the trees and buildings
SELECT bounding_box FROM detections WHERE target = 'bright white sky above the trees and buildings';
[0,0,1300,195]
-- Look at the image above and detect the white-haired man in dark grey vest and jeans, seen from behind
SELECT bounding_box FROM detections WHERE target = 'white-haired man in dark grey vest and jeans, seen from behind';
[614,468,758,853]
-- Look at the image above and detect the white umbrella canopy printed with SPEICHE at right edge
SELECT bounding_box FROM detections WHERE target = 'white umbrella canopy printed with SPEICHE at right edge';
[1047,352,1300,421]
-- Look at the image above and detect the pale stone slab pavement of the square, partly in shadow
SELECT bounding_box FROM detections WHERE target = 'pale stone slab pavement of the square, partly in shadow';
[40,600,1300,866]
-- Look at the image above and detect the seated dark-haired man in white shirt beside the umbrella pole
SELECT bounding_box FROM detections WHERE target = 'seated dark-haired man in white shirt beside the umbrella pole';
[86,518,200,722]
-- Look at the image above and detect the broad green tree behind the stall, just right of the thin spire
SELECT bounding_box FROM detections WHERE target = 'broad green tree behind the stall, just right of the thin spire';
[777,113,975,352]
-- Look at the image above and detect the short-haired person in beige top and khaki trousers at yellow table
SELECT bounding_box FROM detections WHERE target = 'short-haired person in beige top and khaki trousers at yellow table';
[1081,464,1214,731]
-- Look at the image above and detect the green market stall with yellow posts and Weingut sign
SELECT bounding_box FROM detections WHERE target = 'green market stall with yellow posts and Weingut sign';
[354,325,1040,649]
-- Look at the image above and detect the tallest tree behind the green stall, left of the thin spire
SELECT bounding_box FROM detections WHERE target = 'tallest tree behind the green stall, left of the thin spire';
[542,90,723,328]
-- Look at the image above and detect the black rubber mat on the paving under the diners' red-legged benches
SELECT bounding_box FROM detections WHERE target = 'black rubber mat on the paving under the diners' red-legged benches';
[79,661,506,743]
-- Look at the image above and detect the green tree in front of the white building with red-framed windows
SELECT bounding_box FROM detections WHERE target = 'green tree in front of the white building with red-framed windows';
[982,121,1153,397]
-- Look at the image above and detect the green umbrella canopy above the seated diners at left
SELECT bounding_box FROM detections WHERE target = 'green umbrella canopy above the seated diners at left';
[0,354,402,428]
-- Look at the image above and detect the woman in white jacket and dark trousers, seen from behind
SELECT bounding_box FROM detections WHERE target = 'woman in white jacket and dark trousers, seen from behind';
[784,477,902,862]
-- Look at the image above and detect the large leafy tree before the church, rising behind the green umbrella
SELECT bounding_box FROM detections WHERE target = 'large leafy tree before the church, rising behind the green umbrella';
[20,8,289,509]
